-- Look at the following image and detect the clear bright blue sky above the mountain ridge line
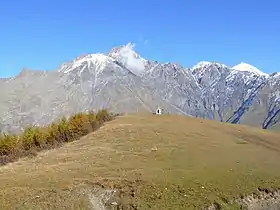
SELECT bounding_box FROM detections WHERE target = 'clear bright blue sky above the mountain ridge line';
[0,0,280,77]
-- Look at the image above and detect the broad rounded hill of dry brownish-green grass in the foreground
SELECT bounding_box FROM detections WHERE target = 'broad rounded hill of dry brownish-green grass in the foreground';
[0,115,280,209]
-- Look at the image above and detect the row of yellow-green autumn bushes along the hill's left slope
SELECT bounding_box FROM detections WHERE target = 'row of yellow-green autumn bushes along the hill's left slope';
[0,109,114,165]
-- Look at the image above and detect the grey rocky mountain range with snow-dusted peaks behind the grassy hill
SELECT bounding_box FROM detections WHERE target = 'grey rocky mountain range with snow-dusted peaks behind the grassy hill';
[0,44,280,132]
